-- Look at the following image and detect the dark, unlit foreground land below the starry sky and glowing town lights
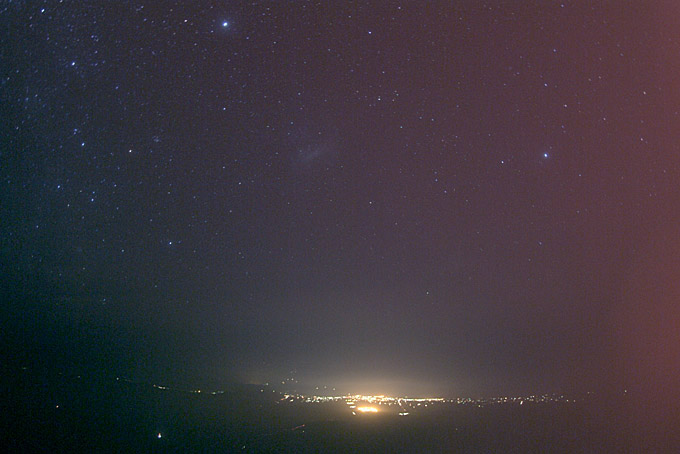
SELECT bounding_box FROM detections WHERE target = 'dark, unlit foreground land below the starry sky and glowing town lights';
[0,370,680,453]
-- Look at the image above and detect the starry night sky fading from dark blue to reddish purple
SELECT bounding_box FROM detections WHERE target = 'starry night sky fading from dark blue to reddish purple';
[0,1,680,395]
